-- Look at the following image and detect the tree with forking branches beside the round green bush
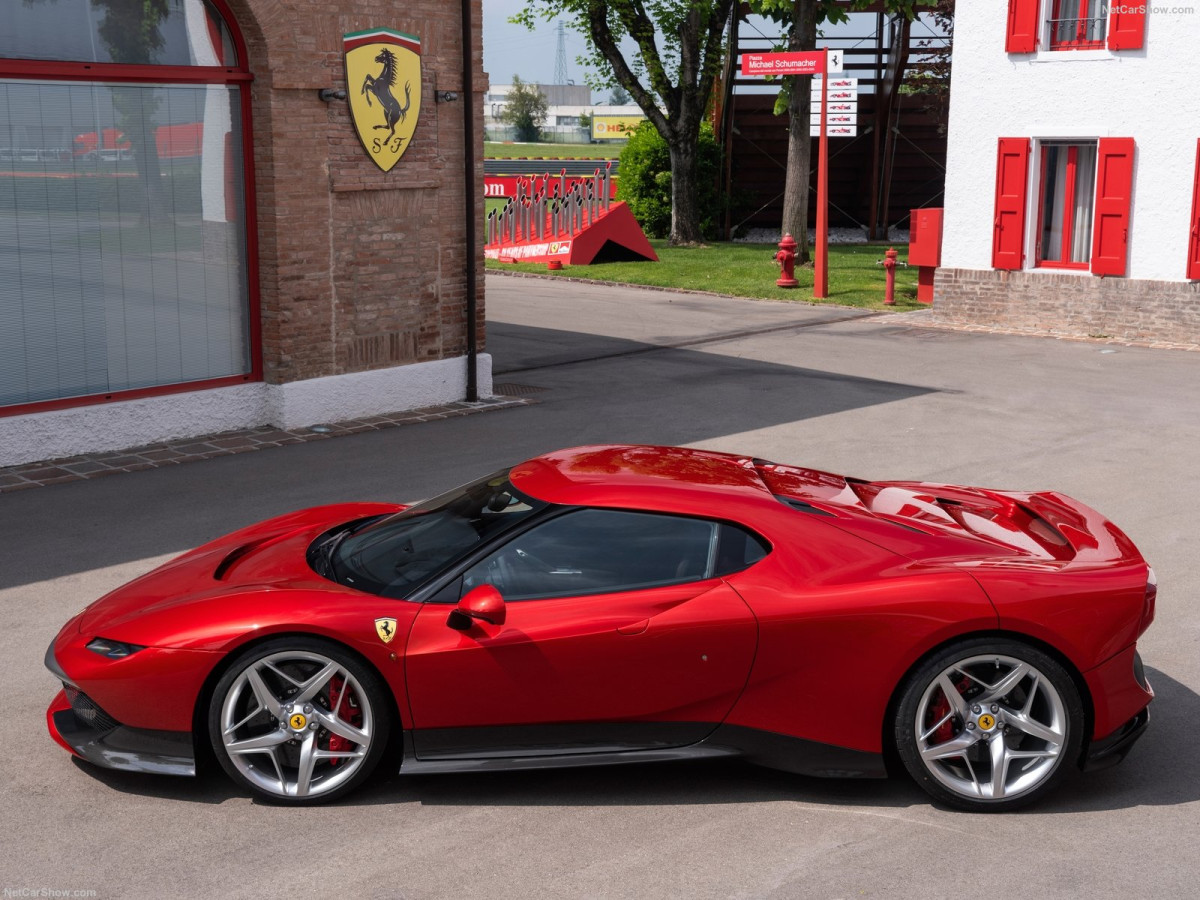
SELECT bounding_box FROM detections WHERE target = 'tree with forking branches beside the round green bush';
[512,0,733,244]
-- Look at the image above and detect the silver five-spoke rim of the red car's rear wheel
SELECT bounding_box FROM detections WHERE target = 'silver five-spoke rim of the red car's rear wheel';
[913,654,1070,800]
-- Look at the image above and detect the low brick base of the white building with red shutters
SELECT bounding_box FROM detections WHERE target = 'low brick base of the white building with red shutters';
[931,269,1200,343]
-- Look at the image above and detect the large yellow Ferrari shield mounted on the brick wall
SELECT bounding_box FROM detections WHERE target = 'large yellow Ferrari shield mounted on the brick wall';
[342,28,421,172]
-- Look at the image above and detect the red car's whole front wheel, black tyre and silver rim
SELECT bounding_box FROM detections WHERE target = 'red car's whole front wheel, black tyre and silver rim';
[209,637,390,804]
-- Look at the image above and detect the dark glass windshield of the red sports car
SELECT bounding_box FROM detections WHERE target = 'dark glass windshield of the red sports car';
[329,469,548,595]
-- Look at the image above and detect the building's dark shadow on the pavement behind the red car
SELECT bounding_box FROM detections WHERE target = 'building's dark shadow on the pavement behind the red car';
[0,325,932,590]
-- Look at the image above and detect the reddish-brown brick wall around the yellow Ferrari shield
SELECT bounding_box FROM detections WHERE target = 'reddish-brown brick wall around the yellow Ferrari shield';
[228,0,487,383]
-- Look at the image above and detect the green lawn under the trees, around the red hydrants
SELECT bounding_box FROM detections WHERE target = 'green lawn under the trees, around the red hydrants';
[487,240,924,310]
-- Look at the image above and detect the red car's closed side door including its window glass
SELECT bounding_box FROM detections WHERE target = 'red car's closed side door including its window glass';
[406,509,757,758]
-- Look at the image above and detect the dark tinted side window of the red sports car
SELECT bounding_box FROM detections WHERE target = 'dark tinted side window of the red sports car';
[463,509,764,601]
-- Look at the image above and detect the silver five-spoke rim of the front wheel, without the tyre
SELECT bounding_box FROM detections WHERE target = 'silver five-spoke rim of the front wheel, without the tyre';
[220,649,374,798]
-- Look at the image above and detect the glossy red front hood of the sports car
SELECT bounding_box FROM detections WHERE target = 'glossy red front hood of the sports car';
[79,503,403,646]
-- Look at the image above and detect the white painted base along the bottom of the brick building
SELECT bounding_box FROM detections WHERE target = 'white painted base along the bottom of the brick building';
[0,353,492,466]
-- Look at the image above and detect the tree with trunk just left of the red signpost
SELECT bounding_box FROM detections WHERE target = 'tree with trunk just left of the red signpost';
[750,0,935,262]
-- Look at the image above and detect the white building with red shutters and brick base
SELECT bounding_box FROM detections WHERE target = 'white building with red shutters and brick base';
[934,0,1200,342]
